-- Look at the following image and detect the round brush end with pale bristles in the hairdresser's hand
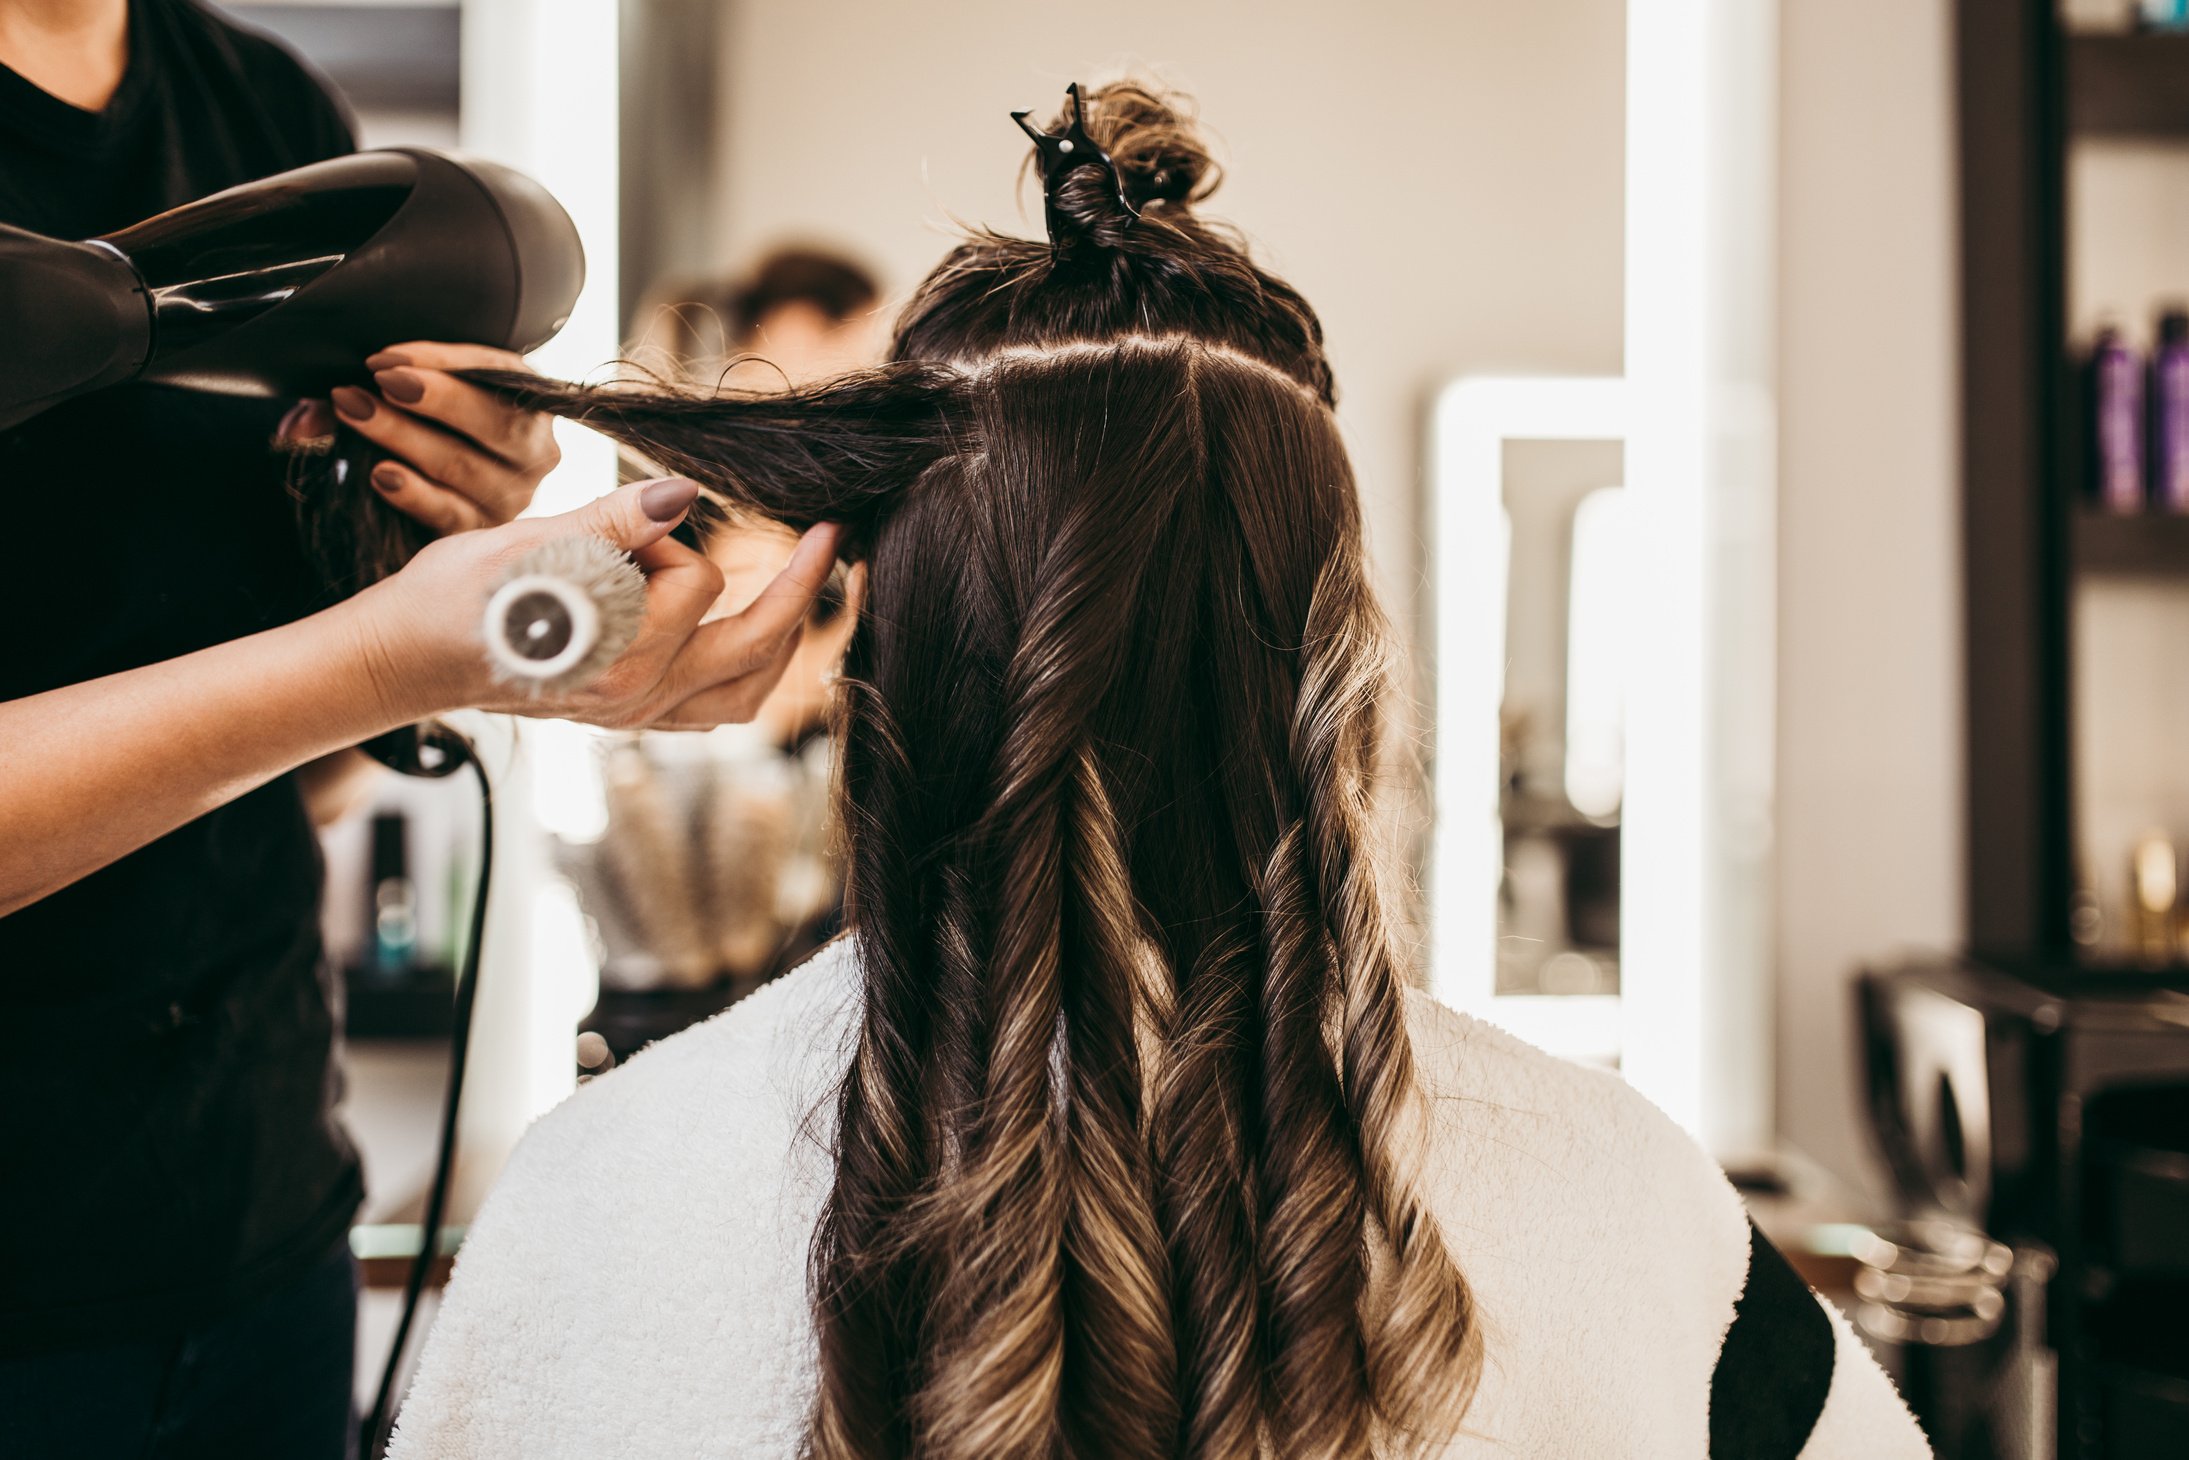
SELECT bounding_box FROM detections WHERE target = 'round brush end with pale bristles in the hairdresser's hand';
[486,534,646,696]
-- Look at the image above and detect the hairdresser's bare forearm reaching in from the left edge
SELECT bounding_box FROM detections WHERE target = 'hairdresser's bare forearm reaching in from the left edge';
[0,600,447,915]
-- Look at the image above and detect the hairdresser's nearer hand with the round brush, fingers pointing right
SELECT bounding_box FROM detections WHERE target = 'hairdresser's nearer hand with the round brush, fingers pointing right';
[350,477,838,729]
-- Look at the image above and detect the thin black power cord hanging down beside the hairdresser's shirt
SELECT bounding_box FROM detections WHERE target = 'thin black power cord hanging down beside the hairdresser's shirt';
[359,722,495,1460]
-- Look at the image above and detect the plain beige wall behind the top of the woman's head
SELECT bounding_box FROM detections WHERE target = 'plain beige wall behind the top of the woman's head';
[720,0,1624,626]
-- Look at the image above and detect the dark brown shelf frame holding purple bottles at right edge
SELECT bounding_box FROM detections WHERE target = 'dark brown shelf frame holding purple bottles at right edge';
[1955,11,2189,967]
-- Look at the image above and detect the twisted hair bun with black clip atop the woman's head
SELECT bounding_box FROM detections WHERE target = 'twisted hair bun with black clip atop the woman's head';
[1011,81,1217,256]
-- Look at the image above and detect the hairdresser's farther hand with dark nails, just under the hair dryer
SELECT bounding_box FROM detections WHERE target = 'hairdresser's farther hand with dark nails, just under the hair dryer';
[333,341,563,536]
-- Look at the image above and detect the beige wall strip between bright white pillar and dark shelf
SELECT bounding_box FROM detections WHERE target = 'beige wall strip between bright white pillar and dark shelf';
[1777,0,1964,1175]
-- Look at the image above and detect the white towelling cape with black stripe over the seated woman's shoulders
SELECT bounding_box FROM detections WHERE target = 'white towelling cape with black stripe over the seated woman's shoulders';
[390,941,1931,1460]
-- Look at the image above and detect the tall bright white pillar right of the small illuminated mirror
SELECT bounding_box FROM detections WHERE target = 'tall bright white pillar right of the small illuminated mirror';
[1620,0,1777,1151]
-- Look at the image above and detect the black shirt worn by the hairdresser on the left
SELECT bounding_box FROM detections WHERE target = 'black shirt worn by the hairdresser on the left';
[0,0,361,1353]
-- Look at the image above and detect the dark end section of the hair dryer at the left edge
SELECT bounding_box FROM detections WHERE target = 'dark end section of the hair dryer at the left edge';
[0,223,151,429]
